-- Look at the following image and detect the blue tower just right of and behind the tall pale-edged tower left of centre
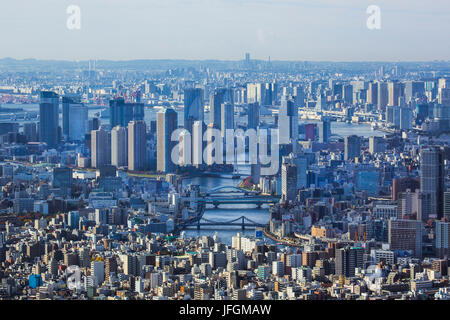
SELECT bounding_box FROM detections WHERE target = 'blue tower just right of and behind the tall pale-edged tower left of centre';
[184,88,204,133]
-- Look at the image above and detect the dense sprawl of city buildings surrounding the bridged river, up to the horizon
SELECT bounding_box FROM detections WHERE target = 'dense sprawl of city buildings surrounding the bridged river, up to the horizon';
[0,56,450,300]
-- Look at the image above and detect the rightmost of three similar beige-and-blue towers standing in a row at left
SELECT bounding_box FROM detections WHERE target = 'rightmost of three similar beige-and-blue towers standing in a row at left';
[128,120,147,171]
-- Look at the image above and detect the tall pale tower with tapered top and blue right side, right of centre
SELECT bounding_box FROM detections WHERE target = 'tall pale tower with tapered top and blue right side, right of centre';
[278,96,298,144]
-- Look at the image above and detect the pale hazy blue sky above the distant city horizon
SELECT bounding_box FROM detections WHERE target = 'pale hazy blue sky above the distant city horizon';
[0,0,450,61]
